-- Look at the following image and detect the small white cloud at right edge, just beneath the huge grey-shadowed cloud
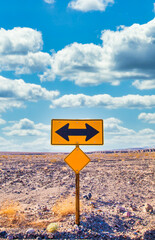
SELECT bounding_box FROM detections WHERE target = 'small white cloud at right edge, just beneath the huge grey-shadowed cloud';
[132,80,155,90]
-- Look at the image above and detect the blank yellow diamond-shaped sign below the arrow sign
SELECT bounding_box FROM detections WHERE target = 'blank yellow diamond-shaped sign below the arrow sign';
[65,147,90,173]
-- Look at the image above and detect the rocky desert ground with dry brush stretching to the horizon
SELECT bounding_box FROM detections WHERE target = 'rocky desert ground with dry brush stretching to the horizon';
[0,149,155,240]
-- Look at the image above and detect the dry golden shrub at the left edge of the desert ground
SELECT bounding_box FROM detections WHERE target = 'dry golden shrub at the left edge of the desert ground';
[0,201,25,227]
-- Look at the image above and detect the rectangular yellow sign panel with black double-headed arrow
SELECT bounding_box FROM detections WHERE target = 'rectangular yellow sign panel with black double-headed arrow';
[51,119,103,145]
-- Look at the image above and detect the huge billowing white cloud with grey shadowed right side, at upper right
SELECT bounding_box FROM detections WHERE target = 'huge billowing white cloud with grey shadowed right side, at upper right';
[42,19,155,86]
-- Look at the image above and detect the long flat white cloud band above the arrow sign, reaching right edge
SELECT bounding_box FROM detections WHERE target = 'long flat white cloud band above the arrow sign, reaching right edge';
[50,94,155,109]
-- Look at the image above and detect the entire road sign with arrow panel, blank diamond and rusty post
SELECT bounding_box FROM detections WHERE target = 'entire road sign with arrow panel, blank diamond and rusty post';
[51,119,103,225]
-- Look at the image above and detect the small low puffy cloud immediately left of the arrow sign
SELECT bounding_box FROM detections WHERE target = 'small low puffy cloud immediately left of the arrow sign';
[3,118,50,136]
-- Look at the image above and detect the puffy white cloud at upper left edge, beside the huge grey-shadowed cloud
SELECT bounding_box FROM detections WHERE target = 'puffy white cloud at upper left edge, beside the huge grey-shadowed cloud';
[0,27,51,77]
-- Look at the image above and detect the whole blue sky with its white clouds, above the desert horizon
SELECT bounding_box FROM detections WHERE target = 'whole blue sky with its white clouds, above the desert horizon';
[0,0,155,152]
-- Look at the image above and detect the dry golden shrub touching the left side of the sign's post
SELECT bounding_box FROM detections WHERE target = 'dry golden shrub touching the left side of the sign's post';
[52,196,81,217]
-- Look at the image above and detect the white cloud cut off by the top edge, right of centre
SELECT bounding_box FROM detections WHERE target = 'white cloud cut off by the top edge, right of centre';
[68,0,114,12]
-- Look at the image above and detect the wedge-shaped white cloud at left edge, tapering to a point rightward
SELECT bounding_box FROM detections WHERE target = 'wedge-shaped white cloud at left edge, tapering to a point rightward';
[0,76,59,112]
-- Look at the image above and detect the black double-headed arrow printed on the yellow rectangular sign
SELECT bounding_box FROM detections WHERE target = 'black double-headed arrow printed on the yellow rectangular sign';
[56,123,99,141]
